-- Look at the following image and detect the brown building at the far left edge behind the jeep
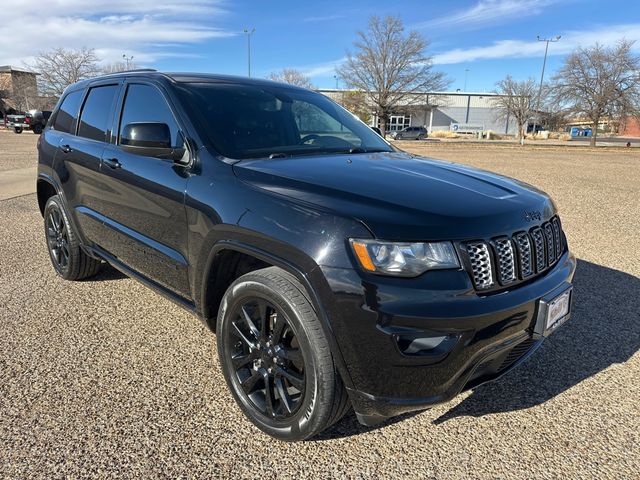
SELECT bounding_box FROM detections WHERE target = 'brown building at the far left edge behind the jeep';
[0,65,40,114]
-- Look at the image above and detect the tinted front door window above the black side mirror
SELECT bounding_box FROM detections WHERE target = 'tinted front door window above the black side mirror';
[118,84,182,147]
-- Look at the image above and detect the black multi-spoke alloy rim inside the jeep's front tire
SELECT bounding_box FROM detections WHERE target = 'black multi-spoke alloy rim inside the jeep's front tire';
[226,298,305,419]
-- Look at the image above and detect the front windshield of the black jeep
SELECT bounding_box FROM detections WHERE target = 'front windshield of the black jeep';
[179,83,393,159]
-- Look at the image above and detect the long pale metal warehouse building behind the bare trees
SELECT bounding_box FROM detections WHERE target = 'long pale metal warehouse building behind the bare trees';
[318,89,518,135]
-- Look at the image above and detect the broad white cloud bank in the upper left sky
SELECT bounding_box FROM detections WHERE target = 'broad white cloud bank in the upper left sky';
[0,0,235,66]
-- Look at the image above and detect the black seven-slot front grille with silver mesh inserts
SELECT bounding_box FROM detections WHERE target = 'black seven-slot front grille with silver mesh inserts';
[462,217,564,290]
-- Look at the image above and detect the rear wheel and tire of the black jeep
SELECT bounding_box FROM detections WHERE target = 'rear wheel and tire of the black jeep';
[44,195,102,280]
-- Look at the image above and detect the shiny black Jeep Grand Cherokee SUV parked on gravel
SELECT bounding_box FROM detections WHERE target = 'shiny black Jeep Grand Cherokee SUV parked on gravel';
[37,71,575,440]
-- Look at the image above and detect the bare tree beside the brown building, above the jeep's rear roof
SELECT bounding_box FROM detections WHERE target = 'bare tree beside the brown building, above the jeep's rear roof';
[30,47,102,97]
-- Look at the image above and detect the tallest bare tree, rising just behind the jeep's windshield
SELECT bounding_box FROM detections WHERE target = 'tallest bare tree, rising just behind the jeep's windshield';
[337,16,449,135]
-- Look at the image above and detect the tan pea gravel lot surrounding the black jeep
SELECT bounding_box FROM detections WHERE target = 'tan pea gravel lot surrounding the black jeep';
[0,131,640,479]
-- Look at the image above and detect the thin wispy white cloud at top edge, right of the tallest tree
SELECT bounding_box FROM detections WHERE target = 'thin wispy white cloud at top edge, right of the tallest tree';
[412,0,560,30]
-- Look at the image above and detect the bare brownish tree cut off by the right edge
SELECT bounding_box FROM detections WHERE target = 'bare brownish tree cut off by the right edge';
[553,40,640,146]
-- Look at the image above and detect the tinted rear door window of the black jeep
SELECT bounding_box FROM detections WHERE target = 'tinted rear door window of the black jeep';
[78,85,119,142]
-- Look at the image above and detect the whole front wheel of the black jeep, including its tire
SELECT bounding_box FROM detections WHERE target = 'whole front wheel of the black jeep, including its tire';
[216,267,351,441]
